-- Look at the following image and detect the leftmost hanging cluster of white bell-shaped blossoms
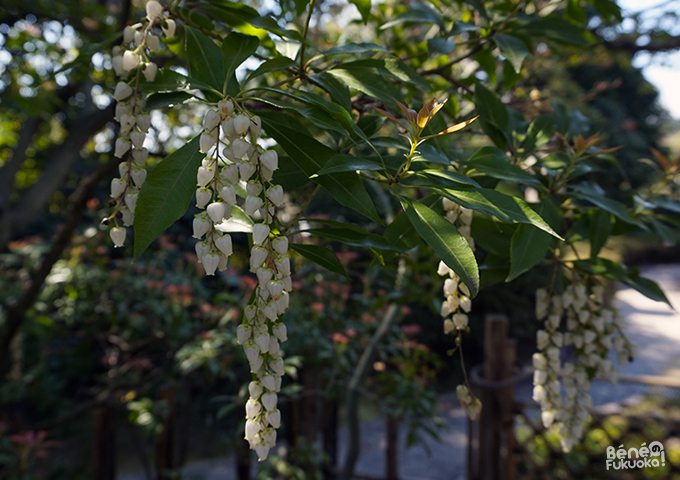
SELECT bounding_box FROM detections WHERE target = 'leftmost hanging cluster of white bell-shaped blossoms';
[104,0,175,247]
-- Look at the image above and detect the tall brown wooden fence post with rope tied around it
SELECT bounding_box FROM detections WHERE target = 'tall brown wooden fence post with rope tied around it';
[478,315,508,480]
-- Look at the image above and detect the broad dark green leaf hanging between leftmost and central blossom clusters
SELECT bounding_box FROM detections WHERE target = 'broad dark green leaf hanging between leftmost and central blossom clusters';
[134,137,205,260]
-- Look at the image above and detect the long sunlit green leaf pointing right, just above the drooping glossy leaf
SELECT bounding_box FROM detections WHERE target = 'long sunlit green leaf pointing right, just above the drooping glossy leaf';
[439,188,563,240]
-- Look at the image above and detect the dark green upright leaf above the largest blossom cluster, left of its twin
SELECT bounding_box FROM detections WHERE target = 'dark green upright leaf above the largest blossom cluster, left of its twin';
[184,25,225,92]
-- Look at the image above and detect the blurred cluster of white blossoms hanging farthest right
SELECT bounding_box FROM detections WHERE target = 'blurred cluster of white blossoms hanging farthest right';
[533,280,633,452]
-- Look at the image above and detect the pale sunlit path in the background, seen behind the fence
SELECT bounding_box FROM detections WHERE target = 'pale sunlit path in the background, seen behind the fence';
[118,265,680,480]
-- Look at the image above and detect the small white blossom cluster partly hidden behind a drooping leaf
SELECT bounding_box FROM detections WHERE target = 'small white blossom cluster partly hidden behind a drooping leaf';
[437,198,475,334]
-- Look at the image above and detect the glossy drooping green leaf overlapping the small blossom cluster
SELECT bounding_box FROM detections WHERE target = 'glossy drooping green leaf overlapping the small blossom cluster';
[400,197,479,297]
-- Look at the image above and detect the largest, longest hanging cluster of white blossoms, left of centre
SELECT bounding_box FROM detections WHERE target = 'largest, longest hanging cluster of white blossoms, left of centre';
[193,99,292,461]
